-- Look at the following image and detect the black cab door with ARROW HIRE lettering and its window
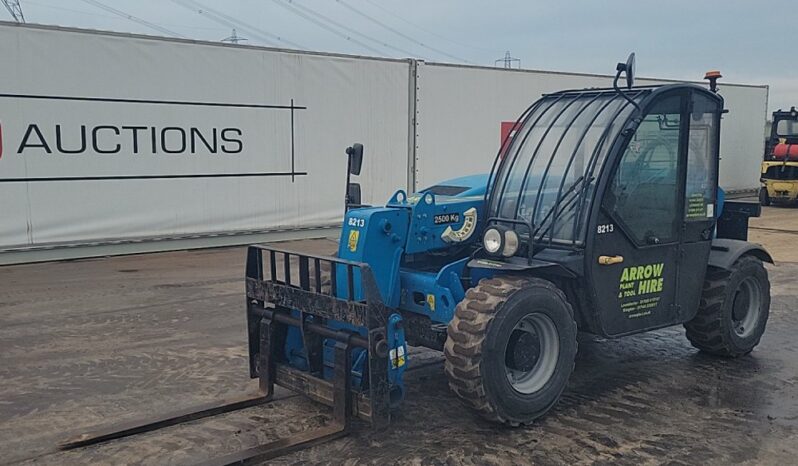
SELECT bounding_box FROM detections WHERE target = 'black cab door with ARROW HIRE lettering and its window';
[586,90,689,336]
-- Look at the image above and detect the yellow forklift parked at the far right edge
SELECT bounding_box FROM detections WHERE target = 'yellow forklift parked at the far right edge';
[759,107,798,206]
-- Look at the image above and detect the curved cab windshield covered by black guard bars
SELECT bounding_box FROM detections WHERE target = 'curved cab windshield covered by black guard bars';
[490,89,650,243]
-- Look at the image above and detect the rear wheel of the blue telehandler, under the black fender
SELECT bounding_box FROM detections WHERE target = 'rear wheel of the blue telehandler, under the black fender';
[684,256,770,358]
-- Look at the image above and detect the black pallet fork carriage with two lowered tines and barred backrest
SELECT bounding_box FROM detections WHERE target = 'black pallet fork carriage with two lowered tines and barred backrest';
[59,245,390,465]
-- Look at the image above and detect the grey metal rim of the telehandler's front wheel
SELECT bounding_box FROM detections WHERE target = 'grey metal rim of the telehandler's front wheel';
[504,312,560,395]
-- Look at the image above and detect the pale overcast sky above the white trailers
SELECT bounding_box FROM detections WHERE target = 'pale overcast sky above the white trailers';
[6,0,798,110]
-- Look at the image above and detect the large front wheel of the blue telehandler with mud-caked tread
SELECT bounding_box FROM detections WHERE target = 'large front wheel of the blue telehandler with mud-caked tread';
[444,277,577,426]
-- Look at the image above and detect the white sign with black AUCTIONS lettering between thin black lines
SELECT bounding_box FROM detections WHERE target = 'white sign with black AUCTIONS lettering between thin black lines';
[0,94,306,183]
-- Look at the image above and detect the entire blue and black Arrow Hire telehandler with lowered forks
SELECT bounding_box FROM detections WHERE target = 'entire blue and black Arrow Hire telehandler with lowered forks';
[66,54,772,463]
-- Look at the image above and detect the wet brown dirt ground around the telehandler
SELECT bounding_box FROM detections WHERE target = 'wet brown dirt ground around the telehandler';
[0,207,798,465]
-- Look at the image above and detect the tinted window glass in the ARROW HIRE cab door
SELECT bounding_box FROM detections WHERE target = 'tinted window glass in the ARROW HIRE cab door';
[604,95,683,244]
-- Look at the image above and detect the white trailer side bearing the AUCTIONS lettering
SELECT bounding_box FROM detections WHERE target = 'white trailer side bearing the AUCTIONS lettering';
[0,24,409,258]
